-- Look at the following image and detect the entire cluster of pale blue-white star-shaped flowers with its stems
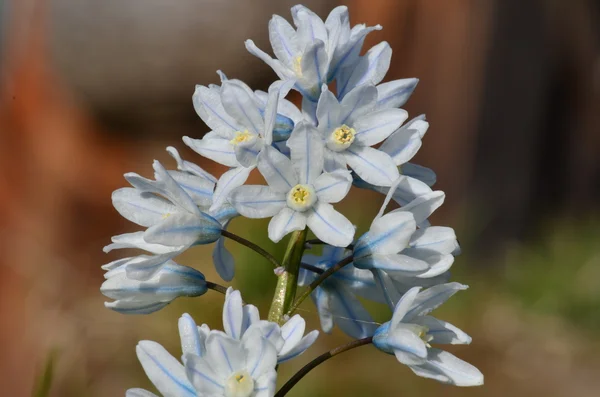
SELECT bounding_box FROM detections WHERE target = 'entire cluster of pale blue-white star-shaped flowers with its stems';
[101,5,483,397]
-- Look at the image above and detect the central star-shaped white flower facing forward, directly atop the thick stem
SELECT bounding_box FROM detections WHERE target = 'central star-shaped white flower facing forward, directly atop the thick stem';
[229,122,354,246]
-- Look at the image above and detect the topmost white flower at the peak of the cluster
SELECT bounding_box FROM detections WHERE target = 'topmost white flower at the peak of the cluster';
[246,5,380,102]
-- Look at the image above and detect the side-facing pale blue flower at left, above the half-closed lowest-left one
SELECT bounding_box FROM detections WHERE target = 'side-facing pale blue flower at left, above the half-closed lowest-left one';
[109,158,223,280]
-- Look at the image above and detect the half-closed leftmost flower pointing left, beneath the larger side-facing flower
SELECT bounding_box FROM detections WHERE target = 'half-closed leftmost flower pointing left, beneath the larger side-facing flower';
[100,258,207,314]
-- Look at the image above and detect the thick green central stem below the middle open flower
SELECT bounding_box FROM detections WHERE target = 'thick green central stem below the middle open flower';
[268,229,307,323]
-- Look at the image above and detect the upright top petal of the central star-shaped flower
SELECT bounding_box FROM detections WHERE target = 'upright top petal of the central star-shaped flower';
[287,122,324,185]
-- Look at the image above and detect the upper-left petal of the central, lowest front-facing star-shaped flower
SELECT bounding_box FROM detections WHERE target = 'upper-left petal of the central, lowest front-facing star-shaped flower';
[258,146,298,193]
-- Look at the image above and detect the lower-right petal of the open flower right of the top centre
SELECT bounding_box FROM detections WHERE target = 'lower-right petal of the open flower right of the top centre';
[343,144,400,186]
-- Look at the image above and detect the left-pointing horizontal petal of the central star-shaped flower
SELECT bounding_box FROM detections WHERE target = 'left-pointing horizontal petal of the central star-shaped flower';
[229,185,286,218]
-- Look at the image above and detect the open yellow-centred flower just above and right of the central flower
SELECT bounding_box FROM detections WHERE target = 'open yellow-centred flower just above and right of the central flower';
[317,85,408,186]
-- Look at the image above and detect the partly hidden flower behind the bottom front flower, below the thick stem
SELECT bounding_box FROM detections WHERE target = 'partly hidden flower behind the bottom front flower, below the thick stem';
[223,287,319,363]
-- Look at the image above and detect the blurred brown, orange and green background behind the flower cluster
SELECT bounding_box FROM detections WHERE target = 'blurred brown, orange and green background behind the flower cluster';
[0,0,600,397]
